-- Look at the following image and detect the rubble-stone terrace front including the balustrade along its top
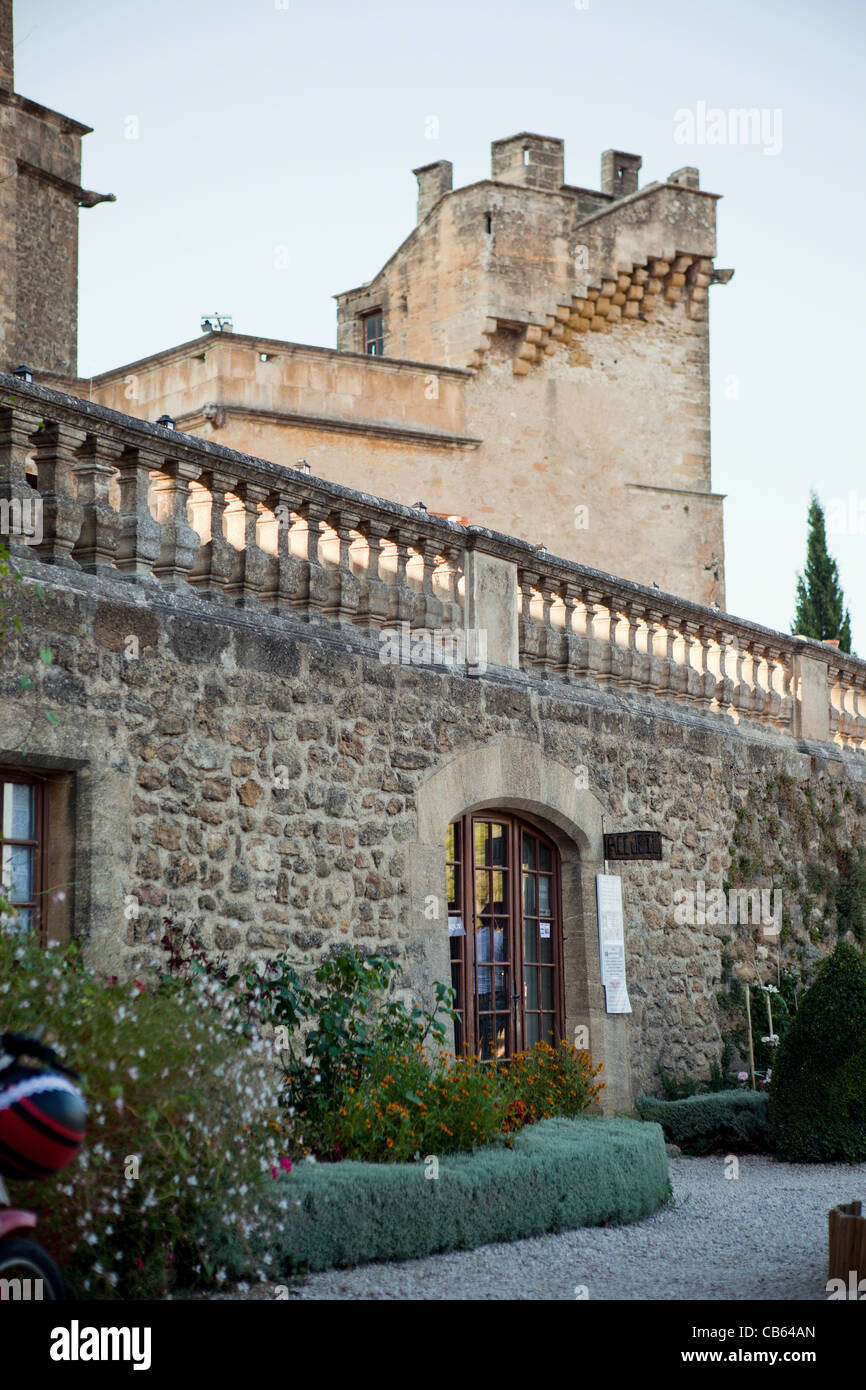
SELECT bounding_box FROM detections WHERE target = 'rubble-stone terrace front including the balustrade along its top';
[0,377,866,1111]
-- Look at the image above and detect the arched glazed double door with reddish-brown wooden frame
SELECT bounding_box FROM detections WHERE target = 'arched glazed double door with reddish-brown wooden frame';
[446,810,564,1059]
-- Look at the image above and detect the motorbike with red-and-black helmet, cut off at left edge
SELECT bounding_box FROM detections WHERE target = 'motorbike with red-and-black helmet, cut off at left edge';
[0,1030,86,1301]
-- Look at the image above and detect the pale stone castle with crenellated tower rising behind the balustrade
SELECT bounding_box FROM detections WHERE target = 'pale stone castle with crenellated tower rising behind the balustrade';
[0,0,731,605]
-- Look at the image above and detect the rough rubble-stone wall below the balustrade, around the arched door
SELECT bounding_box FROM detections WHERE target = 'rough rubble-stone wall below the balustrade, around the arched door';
[6,553,866,1104]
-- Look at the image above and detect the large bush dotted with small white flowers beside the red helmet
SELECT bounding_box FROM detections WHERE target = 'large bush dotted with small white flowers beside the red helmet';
[0,931,279,1298]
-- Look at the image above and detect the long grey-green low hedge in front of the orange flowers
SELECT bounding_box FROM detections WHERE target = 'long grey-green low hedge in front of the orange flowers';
[214,1116,670,1277]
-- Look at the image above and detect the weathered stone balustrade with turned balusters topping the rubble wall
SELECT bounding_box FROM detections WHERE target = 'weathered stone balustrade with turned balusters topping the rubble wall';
[0,374,866,753]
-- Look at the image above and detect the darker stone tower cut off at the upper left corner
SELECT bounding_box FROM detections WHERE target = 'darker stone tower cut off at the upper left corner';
[0,0,114,377]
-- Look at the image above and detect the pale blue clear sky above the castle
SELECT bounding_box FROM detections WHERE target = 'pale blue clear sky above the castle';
[15,0,866,653]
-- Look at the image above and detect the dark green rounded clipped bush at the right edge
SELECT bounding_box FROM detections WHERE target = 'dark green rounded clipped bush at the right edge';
[770,941,866,1163]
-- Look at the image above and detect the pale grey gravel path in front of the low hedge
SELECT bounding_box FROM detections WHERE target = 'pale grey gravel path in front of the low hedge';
[250,1156,866,1301]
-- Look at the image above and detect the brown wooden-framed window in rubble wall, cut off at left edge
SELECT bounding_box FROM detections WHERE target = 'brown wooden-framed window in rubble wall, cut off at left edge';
[0,767,72,945]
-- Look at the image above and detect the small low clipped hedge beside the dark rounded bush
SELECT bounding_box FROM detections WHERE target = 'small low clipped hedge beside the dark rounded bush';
[635,1091,770,1154]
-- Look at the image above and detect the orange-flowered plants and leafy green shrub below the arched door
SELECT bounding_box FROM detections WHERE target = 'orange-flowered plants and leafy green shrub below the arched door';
[264,952,602,1162]
